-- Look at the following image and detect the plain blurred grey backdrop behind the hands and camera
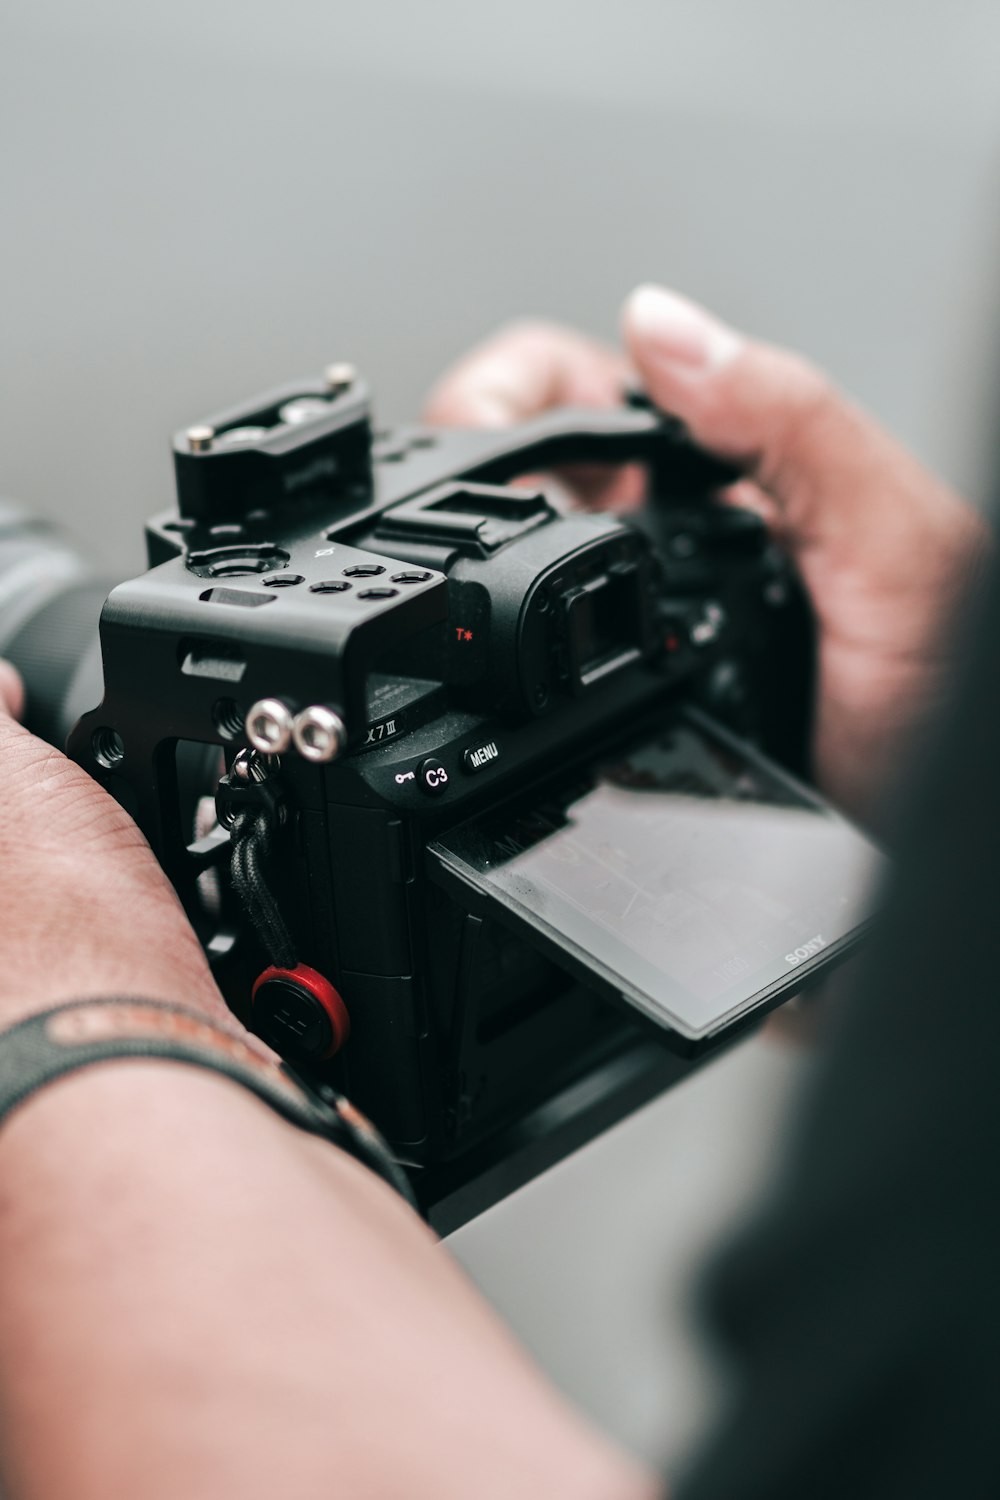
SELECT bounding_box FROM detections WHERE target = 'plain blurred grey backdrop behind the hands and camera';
[0,0,1000,1464]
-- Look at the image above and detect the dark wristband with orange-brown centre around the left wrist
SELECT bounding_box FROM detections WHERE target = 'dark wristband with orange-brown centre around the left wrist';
[0,998,414,1206]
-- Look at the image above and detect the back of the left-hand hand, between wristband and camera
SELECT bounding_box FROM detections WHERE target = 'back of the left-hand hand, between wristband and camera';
[0,662,228,1028]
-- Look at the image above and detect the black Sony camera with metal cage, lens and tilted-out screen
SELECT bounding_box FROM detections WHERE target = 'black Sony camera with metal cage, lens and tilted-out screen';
[0,366,871,1229]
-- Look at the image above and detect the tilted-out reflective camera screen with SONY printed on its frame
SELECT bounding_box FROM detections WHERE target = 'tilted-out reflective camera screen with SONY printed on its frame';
[432,713,882,1040]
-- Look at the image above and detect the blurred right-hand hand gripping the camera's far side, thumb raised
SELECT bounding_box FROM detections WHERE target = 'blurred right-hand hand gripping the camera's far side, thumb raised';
[427,287,990,824]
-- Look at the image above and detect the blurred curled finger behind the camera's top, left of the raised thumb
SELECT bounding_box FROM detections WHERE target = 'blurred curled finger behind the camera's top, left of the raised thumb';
[424,323,628,428]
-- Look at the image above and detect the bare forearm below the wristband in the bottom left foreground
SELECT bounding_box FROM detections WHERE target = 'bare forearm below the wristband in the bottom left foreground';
[0,1062,657,1500]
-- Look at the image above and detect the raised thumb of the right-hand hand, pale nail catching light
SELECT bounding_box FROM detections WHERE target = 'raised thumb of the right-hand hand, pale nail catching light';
[622,287,958,563]
